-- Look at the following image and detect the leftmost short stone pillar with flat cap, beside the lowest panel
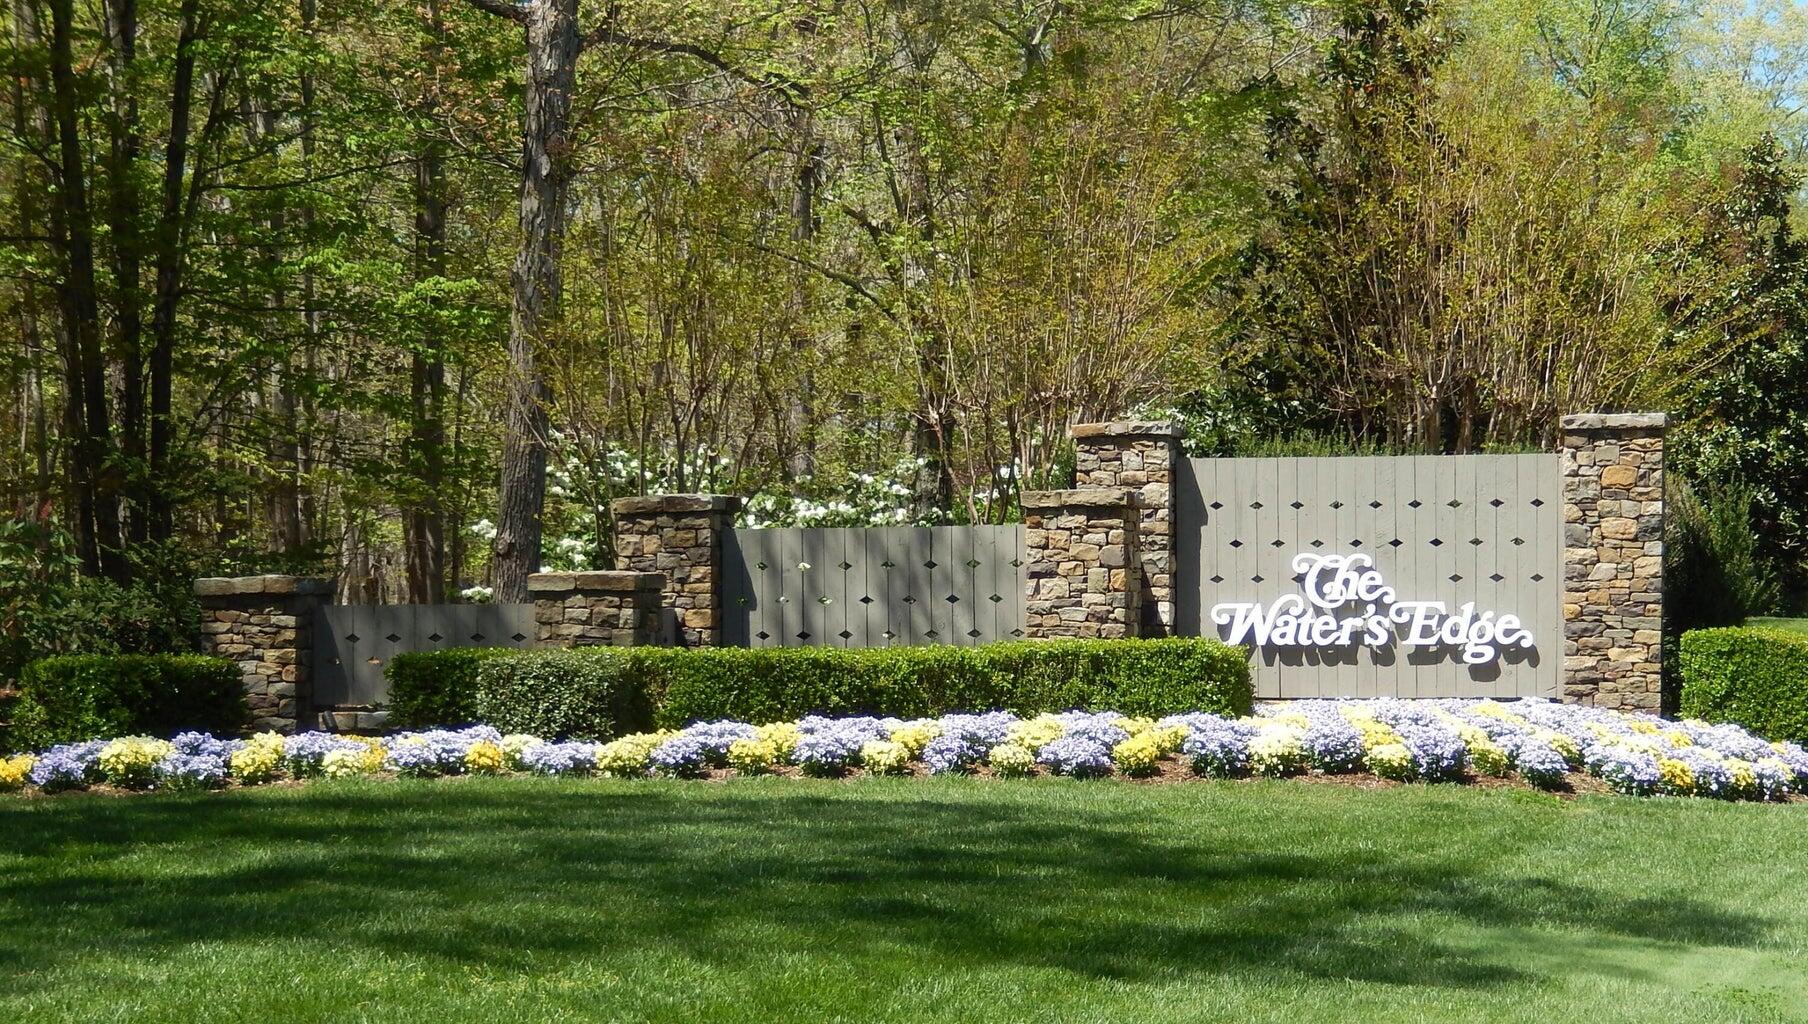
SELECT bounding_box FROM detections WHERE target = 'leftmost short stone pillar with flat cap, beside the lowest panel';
[195,575,333,733]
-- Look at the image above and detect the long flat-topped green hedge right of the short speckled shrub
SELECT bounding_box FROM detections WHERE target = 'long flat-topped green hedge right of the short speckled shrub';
[643,639,1253,727]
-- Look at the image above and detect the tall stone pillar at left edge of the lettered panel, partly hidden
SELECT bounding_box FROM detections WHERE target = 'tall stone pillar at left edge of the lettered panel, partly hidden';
[1072,420,1184,637]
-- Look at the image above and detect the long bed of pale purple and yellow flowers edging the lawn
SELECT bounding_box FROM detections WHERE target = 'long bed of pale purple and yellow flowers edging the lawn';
[10,700,1808,800]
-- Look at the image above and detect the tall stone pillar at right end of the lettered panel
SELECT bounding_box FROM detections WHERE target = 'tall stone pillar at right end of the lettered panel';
[1560,412,1665,713]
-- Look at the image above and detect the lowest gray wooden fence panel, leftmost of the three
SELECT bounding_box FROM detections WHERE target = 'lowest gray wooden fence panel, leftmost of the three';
[313,604,533,707]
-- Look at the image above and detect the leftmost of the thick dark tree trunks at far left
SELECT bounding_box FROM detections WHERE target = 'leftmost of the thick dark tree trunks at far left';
[49,0,127,579]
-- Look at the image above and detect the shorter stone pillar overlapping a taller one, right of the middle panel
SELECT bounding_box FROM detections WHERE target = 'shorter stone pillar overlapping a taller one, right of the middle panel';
[1023,487,1143,639]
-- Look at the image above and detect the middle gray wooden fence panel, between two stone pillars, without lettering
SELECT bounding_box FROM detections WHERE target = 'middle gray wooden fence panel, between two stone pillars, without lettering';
[721,526,1023,648]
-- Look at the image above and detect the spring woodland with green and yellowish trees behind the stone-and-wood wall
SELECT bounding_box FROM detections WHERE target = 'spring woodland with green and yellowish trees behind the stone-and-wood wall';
[0,0,1808,684]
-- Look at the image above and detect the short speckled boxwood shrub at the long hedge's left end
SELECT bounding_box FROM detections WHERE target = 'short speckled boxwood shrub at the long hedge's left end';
[476,648,653,740]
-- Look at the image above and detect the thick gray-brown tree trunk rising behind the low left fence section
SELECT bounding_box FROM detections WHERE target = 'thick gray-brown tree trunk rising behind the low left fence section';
[479,0,584,602]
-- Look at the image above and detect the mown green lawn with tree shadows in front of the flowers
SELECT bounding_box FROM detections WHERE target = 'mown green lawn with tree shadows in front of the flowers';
[0,780,1808,1024]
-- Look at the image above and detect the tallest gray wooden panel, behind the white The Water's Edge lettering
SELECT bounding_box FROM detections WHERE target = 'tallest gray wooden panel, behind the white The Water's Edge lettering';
[1175,454,1564,697]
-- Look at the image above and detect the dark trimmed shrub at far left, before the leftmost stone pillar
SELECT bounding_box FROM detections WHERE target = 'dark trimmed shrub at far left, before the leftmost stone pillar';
[13,655,250,749]
